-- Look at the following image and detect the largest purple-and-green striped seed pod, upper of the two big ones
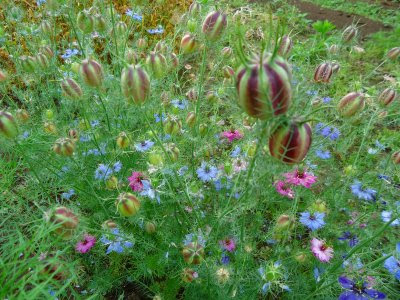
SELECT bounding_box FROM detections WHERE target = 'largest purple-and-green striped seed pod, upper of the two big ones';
[236,55,292,119]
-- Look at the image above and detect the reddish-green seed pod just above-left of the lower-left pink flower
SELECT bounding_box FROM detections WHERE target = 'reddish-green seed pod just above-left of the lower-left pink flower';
[50,206,79,238]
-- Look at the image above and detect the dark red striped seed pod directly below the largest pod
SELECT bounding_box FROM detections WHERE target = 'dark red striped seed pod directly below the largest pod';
[269,122,312,164]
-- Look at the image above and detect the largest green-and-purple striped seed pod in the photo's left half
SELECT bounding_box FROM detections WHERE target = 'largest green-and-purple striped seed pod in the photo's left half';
[121,65,150,104]
